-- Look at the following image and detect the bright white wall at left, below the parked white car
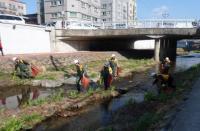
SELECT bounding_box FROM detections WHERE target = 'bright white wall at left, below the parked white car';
[0,23,51,54]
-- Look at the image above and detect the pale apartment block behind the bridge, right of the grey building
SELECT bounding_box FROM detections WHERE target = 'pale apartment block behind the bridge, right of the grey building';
[101,0,136,27]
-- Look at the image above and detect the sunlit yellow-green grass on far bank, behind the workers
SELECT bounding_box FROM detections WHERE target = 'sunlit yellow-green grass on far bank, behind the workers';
[0,59,155,86]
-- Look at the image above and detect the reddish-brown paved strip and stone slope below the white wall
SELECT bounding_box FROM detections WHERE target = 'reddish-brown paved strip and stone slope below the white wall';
[0,52,126,73]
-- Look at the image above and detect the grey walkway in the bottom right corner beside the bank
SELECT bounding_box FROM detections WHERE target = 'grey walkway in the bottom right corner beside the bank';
[168,78,200,131]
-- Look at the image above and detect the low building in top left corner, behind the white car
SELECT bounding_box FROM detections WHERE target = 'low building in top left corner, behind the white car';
[0,0,26,16]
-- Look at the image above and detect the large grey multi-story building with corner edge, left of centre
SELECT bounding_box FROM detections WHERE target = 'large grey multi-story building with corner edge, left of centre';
[38,0,101,23]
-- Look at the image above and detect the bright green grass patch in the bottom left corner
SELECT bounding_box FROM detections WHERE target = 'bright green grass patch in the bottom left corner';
[0,114,43,131]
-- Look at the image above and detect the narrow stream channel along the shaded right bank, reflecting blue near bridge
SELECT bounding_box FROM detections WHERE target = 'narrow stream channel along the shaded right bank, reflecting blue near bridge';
[33,54,200,131]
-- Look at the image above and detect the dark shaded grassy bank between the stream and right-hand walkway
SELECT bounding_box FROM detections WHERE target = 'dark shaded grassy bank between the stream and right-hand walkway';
[101,64,200,131]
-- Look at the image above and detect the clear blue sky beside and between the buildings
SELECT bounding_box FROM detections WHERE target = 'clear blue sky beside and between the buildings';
[22,0,200,19]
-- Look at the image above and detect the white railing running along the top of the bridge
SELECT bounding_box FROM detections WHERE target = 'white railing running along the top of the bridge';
[56,19,200,29]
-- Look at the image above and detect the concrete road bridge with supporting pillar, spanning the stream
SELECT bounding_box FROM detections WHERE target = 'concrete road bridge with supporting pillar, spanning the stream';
[53,28,200,61]
